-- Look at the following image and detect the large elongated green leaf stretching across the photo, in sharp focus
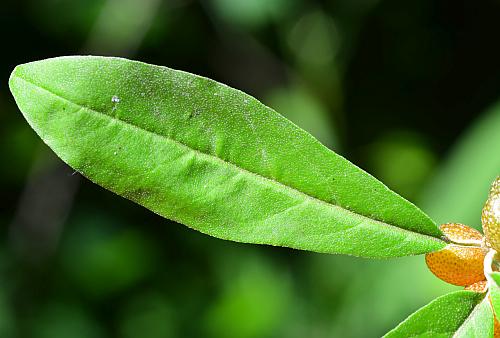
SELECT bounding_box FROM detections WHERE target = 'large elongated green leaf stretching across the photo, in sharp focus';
[9,56,445,257]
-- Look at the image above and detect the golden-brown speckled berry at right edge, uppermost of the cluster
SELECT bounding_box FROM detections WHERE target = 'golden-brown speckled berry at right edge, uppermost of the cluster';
[481,177,500,252]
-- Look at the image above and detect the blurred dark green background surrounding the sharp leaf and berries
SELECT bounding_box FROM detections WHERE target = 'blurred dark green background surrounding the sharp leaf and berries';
[0,0,500,338]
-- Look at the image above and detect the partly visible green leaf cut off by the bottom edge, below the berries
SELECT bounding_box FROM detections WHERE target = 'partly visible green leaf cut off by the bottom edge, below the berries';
[385,291,493,338]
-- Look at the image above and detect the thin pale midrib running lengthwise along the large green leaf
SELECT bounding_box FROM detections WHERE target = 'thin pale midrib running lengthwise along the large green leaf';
[13,72,441,241]
